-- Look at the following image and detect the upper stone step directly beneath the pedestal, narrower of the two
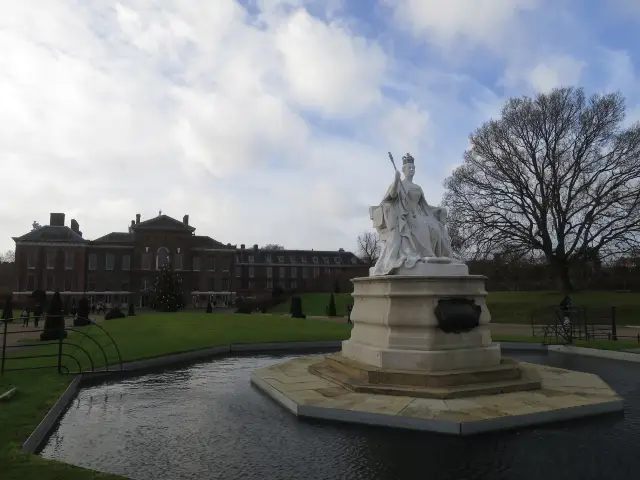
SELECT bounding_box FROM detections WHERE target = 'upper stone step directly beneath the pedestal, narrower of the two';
[325,353,521,388]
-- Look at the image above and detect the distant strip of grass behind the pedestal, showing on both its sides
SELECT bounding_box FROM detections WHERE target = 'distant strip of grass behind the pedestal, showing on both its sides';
[274,291,640,326]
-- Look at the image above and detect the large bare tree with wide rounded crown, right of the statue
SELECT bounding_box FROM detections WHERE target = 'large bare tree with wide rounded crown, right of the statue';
[444,88,640,291]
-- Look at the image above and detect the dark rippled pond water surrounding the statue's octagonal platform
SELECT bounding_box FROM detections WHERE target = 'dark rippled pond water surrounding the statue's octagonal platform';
[41,352,640,480]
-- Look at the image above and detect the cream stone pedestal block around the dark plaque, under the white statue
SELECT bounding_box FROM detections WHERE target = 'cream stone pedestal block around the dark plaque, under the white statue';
[342,275,501,372]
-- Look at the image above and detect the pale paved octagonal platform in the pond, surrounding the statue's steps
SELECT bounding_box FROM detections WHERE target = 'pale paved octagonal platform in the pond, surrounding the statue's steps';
[251,355,623,435]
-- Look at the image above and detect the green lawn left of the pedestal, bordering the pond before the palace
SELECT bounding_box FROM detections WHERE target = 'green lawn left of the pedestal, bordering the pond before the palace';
[0,313,350,480]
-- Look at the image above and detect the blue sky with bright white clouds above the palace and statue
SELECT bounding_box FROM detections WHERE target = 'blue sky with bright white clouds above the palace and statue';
[0,0,640,251]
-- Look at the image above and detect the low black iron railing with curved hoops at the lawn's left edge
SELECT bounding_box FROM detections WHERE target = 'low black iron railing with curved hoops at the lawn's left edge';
[0,318,122,375]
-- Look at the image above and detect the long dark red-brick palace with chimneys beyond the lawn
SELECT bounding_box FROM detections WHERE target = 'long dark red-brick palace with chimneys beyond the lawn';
[13,213,368,307]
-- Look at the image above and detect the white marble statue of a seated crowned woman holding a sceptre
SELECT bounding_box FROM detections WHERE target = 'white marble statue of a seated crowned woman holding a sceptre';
[369,154,468,276]
